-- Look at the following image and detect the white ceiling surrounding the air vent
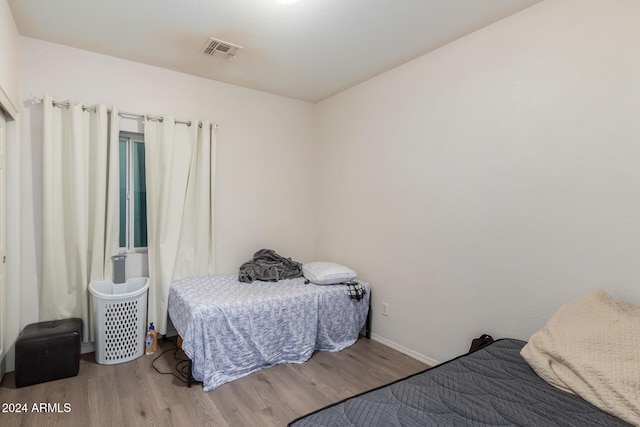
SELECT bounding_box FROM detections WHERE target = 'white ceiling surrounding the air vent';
[8,0,540,102]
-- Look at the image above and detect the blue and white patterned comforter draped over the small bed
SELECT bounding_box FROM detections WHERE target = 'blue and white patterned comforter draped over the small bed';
[169,275,371,391]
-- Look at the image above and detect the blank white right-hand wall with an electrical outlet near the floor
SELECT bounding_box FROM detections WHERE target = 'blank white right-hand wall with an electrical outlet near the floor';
[315,0,640,361]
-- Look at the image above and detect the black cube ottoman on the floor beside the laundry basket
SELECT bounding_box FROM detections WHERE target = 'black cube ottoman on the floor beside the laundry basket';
[16,319,82,387]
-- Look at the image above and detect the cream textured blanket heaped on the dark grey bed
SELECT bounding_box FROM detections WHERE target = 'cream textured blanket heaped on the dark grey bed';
[521,290,640,426]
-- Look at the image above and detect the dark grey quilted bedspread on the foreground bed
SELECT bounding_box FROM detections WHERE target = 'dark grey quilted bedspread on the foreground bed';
[289,339,629,427]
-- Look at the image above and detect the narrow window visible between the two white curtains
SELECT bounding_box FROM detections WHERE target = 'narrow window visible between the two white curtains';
[120,132,147,251]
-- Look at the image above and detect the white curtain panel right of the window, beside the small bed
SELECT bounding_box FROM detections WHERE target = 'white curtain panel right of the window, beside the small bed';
[144,117,216,334]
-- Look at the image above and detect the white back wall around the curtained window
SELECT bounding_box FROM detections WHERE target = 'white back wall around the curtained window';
[20,37,314,325]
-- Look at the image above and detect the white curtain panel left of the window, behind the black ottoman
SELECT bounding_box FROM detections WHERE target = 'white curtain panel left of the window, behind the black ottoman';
[40,95,119,342]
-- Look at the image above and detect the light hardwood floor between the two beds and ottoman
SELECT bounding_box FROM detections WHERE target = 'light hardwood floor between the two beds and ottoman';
[0,337,427,427]
